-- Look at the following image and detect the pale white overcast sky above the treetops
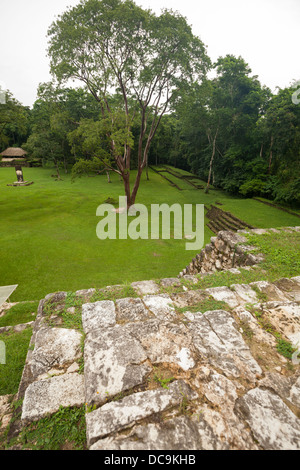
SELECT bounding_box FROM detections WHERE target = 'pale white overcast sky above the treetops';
[0,0,300,106]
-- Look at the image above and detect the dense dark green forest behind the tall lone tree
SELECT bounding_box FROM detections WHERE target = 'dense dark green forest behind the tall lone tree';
[0,2,300,206]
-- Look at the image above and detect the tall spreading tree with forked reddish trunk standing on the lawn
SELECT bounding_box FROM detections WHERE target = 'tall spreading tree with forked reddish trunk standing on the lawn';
[48,0,210,206]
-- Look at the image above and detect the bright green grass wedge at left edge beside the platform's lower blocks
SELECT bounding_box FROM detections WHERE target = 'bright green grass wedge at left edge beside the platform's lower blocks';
[0,328,32,395]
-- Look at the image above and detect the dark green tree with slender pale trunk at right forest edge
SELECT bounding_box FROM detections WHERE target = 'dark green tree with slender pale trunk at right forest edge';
[173,55,269,193]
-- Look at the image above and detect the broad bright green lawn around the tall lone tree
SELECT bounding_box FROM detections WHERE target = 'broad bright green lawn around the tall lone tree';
[0,168,300,301]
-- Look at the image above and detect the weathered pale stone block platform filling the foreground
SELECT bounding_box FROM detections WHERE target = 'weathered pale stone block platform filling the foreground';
[1,275,300,450]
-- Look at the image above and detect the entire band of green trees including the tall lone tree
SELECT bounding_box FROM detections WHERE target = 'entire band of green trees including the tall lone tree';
[0,0,300,206]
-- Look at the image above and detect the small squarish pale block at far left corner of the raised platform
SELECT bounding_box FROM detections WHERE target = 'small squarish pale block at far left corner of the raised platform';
[82,300,116,334]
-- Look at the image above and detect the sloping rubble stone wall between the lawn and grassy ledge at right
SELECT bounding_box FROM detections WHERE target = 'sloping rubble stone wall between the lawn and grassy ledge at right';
[179,229,264,277]
